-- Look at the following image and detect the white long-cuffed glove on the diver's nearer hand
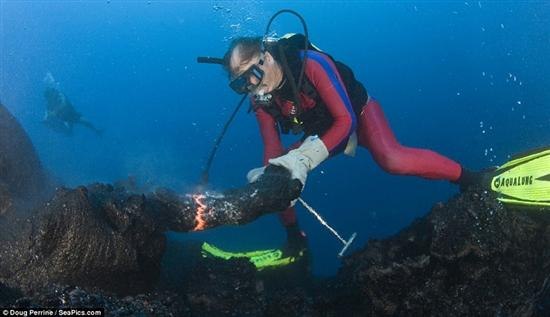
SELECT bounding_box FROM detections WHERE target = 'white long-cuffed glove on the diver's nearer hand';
[270,135,329,188]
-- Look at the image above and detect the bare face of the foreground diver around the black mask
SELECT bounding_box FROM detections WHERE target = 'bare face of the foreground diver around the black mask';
[230,47,283,95]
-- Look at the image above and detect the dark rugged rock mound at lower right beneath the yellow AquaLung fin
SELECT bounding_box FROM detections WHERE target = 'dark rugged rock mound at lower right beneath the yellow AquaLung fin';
[332,192,550,316]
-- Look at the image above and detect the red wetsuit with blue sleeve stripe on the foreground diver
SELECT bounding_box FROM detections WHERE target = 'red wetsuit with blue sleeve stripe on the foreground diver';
[256,50,461,226]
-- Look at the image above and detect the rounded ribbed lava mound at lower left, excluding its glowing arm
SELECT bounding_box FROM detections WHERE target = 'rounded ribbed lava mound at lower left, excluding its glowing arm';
[0,185,168,293]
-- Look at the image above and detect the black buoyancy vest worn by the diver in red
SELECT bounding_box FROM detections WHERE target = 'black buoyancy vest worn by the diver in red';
[261,34,368,138]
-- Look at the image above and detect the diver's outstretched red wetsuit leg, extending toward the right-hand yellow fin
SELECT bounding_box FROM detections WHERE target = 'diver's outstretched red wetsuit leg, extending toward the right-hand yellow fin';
[358,98,462,181]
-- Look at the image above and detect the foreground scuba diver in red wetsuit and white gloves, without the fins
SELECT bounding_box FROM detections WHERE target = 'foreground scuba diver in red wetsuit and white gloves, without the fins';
[223,34,481,256]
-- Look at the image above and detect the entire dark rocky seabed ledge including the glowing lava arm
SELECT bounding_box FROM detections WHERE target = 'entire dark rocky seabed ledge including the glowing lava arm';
[0,105,550,316]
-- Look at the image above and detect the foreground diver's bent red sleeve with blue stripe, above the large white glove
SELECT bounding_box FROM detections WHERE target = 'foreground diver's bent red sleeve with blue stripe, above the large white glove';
[305,51,357,154]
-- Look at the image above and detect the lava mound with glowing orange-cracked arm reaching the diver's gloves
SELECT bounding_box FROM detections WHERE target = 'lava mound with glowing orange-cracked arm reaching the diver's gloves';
[0,177,302,294]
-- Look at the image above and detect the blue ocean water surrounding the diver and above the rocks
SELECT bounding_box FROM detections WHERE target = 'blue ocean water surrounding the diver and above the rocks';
[0,0,550,275]
